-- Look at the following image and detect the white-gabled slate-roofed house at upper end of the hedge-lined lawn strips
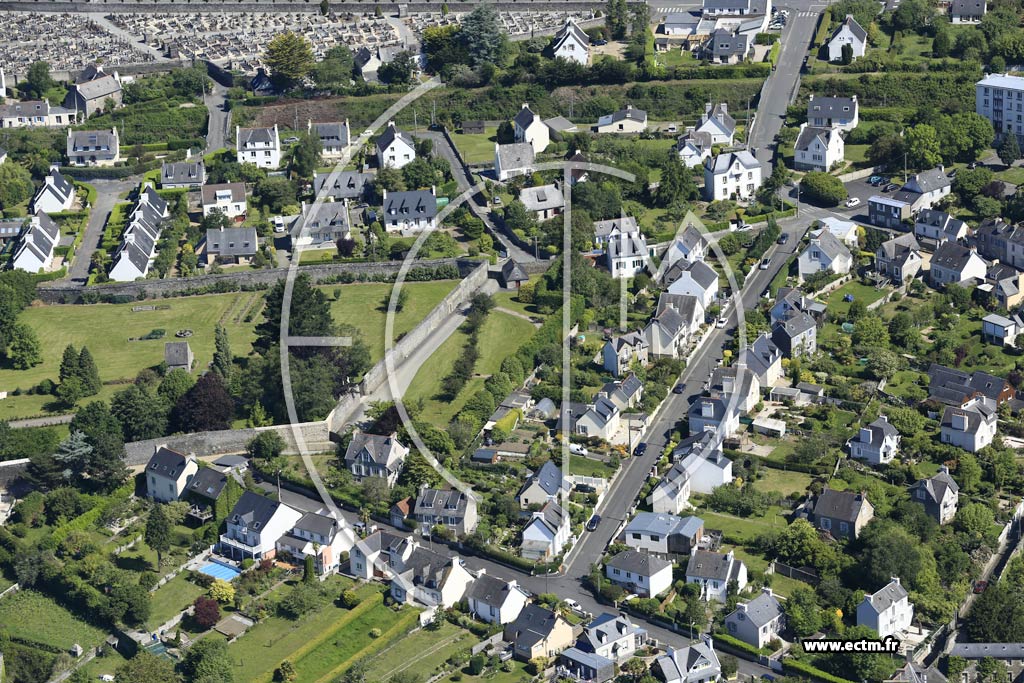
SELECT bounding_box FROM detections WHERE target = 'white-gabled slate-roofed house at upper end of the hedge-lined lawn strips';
[390,545,473,609]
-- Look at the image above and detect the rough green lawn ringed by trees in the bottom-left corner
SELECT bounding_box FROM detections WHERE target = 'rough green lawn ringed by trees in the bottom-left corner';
[0,590,104,651]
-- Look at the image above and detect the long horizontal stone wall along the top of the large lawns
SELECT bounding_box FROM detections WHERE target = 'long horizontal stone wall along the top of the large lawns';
[36,258,480,303]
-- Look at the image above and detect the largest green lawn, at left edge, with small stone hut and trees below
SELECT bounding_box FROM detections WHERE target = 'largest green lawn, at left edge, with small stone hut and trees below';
[0,292,262,420]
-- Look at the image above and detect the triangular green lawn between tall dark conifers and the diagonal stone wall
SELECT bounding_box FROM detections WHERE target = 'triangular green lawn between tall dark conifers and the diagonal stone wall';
[321,280,457,362]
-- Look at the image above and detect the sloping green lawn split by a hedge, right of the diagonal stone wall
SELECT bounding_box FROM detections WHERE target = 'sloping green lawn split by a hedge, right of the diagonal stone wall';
[404,310,536,425]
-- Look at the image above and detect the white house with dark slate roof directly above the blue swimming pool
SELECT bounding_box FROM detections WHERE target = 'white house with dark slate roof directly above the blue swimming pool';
[219,490,303,561]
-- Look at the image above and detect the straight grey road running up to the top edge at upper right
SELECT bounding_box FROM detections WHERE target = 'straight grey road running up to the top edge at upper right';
[750,3,820,167]
